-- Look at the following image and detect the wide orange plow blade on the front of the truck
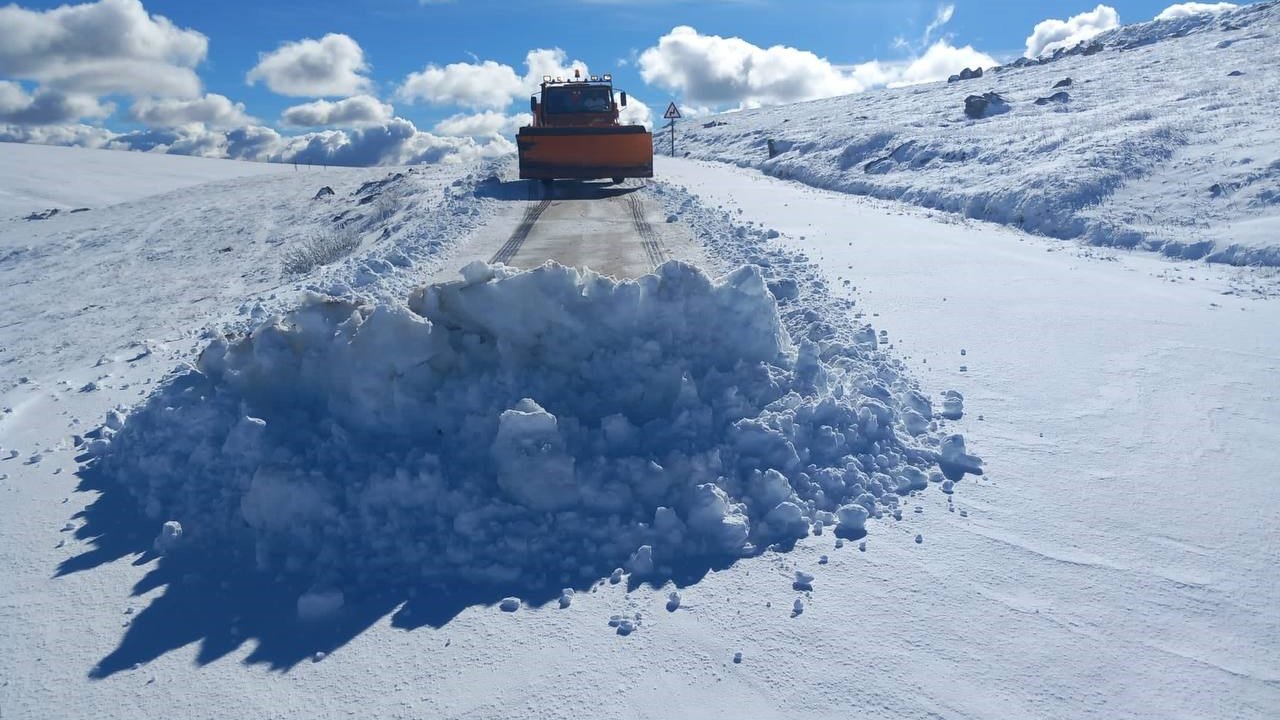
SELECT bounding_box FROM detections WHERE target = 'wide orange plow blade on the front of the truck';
[516,126,653,179]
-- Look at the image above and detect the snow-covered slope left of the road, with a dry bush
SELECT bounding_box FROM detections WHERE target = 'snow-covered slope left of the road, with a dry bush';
[0,156,492,393]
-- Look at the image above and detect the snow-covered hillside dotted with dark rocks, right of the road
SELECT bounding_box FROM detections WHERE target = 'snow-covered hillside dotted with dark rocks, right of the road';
[663,3,1280,265]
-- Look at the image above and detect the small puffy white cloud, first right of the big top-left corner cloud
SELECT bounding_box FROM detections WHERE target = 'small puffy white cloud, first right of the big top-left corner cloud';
[244,32,370,97]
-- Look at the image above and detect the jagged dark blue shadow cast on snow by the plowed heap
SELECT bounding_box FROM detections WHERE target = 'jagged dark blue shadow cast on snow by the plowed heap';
[56,455,732,679]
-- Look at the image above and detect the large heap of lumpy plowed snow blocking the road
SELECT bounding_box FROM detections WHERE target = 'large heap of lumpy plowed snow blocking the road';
[96,261,980,589]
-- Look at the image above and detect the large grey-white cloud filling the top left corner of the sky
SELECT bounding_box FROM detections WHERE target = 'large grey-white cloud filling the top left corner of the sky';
[0,0,209,97]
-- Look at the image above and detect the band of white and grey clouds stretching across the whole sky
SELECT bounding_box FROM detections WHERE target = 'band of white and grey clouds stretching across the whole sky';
[0,0,1235,165]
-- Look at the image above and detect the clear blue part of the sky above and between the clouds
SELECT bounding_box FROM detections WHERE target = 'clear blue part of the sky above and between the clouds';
[80,0,1192,127]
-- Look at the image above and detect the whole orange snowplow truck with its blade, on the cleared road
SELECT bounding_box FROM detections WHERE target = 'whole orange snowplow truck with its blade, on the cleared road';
[516,70,653,182]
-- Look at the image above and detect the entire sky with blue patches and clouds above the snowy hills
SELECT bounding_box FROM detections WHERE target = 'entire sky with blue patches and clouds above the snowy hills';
[0,0,1244,161]
